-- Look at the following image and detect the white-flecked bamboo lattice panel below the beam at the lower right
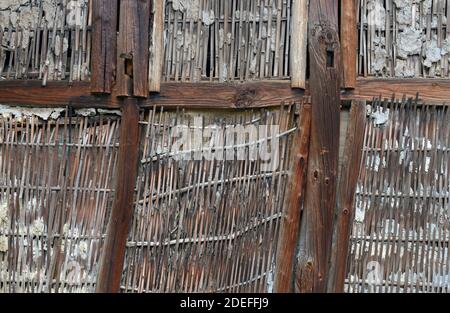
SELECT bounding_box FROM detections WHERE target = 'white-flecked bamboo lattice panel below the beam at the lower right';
[346,100,450,292]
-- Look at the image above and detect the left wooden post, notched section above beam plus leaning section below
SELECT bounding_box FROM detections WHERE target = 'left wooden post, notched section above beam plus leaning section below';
[97,0,151,293]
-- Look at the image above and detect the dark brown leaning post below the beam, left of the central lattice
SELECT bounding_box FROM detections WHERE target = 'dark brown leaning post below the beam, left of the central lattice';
[96,98,139,293]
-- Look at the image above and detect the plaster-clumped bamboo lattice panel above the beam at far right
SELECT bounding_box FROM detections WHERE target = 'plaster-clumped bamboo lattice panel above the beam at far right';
[358,0,450,77]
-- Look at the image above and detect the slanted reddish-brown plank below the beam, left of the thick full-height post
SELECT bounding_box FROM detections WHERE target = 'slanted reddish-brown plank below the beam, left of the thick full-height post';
[274,104,311,293]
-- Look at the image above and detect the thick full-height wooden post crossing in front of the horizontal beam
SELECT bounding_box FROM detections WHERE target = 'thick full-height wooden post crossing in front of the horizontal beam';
[296,0,342,292]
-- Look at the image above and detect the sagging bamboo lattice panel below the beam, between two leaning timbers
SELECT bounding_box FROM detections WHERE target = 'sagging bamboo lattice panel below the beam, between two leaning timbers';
[122,106,296,292]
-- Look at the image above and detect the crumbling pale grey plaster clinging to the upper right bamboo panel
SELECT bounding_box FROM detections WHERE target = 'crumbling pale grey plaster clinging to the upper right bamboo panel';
[368,0,450,78]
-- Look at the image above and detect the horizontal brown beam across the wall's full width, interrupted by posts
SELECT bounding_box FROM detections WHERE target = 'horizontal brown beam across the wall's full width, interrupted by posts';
[0,79,450,109]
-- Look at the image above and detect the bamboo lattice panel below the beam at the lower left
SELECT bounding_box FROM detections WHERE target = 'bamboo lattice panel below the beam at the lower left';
[0,107,119,293]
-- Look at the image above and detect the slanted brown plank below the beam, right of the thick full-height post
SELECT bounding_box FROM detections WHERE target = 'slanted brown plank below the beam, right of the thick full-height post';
[328,101,366,293]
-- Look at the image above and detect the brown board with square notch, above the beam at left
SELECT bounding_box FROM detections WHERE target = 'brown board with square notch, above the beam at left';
[117,0,150,98]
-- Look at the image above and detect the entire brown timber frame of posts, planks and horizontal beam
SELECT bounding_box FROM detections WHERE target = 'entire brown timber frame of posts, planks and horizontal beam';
[0,0,450,292]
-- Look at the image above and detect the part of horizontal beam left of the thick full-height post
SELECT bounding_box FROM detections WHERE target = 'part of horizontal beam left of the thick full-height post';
[0,80,305,109]
